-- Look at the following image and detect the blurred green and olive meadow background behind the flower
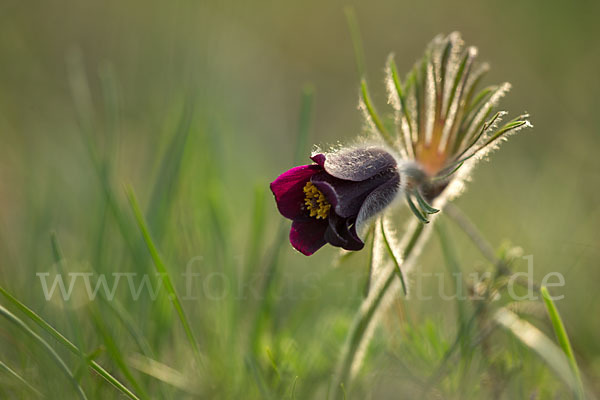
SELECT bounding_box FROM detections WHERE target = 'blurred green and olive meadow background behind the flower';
[0,0,600,398]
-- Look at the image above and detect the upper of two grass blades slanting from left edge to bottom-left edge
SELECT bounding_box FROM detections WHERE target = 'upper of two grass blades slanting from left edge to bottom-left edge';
[0,286,139,400]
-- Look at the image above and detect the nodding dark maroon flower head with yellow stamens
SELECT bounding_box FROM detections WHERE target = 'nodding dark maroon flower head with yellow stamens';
[271,147,400,256]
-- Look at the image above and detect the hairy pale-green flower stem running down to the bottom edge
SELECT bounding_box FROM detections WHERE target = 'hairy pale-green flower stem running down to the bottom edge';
[330,221,432,400]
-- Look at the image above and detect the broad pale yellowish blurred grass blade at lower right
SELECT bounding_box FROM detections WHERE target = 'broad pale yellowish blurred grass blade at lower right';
[492,307,579,393]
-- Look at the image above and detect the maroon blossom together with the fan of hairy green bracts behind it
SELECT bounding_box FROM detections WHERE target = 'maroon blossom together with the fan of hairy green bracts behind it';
[271,32,531,255]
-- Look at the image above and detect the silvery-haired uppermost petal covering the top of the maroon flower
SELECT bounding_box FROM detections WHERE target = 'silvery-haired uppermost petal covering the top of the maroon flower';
[311,147,397,182]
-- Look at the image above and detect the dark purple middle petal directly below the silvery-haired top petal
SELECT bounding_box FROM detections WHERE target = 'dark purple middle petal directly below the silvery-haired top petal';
[310,170,398,218]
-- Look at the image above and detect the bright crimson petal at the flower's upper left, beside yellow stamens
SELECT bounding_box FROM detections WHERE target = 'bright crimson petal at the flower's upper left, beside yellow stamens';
[271,164,322,219]
